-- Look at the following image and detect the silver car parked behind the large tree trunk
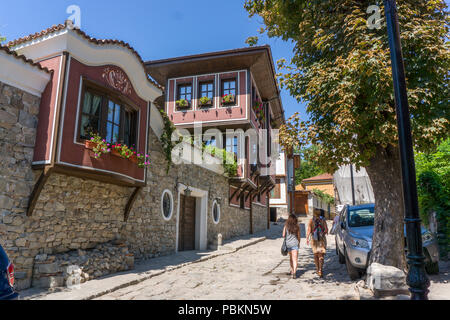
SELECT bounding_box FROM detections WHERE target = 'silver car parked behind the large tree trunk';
[335,203,439,280]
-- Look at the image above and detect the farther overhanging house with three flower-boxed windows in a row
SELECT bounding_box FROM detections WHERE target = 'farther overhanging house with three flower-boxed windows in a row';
[145,46,284,232]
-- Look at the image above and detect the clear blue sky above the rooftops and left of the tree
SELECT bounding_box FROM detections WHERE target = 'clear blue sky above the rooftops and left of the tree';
[0,0,306,118]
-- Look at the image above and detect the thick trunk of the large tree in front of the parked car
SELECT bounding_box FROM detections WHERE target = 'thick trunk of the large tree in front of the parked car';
[366,146,406,271]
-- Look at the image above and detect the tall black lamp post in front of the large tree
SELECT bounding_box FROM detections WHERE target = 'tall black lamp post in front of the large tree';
[384,0,430,300]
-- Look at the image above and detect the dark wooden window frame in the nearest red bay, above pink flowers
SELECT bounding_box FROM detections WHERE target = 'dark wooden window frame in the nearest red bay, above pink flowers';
[77,79,140,149]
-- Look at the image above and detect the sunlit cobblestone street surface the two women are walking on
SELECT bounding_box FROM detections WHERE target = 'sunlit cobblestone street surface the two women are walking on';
[98,219,359,300]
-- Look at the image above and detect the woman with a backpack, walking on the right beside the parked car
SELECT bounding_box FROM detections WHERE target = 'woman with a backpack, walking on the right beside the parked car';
[306,210,328,278]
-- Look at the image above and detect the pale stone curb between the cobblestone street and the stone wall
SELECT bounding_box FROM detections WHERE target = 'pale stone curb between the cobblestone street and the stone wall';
[25,236,267,300]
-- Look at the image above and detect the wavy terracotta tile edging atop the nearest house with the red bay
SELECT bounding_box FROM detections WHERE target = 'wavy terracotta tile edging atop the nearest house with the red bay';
[6,20,164,90]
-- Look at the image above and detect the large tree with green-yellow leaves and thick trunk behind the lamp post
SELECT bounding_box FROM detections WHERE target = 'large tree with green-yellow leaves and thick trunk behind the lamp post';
[244,0,450,269]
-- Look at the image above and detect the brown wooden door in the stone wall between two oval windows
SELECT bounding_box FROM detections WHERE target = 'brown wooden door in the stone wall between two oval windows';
[178,195,195,251]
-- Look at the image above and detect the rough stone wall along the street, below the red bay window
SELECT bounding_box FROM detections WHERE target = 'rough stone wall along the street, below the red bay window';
[0,79,267,290]
